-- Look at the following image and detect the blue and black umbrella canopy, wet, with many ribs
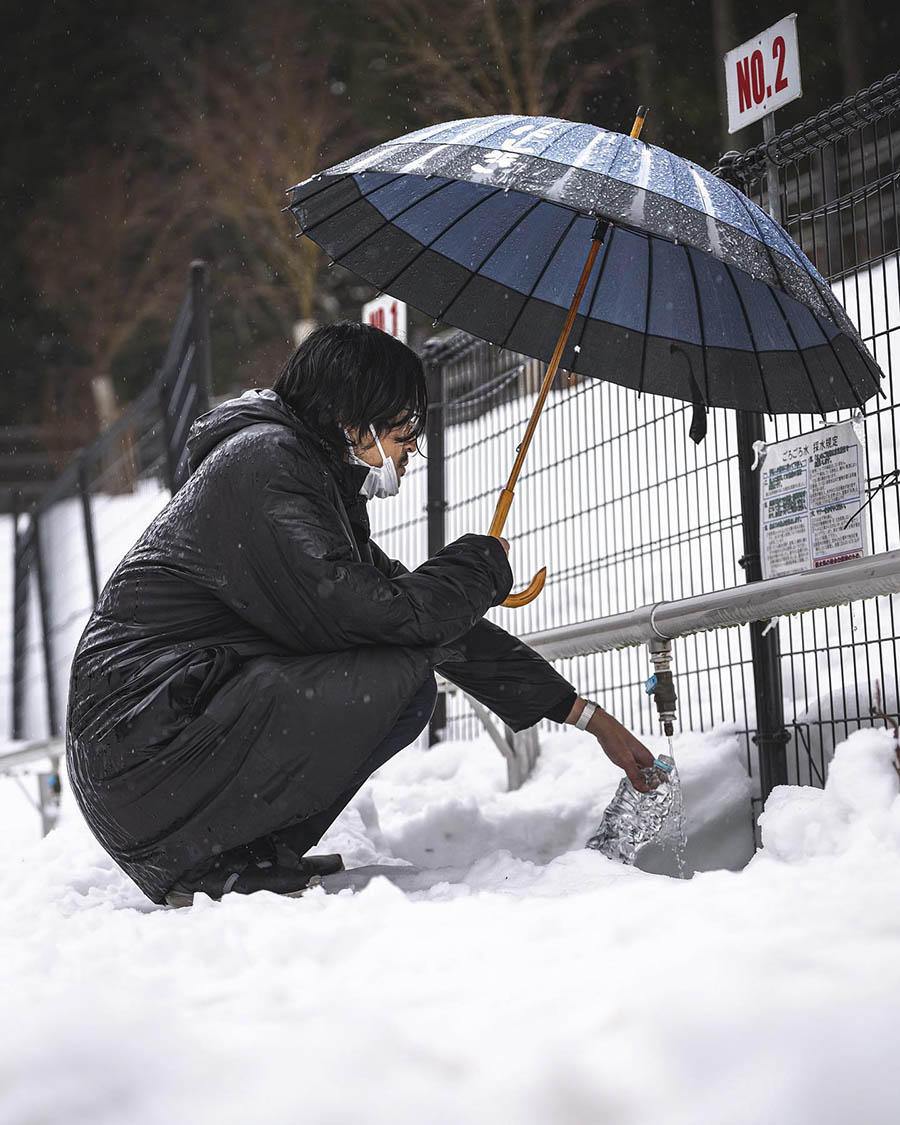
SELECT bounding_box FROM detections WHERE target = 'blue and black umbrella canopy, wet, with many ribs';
[289,116,881,413]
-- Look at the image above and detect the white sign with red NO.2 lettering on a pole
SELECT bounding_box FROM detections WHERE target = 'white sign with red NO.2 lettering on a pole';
[725,15,803,133]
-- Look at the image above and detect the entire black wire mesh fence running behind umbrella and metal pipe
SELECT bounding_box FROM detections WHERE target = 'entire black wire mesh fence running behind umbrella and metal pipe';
[374,77,900,810]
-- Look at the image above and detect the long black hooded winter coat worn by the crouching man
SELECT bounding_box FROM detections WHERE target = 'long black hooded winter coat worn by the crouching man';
[66,392,574,902]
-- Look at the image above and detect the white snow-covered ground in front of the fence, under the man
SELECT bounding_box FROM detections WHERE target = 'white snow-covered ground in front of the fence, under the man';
[0,730,900,1125]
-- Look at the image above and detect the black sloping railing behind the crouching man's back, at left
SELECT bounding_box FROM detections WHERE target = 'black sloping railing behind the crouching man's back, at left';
[7,262,210,739]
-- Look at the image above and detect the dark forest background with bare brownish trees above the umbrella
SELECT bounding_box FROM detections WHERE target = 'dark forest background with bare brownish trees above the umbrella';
[0,0,900,456]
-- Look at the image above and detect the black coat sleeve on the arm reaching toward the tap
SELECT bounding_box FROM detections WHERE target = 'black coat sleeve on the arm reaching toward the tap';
[370,542,576,730]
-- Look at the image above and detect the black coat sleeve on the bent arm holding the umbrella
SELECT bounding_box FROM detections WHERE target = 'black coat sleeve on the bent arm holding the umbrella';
[200,442,512,653]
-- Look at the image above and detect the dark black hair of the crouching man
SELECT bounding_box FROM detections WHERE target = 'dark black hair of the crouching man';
[272,321,428,457]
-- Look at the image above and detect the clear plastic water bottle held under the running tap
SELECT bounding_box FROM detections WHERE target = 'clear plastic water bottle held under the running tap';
[586,754,680,863]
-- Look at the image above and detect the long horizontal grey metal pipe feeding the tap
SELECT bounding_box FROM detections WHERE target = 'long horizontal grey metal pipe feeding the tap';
[522,550,900,660]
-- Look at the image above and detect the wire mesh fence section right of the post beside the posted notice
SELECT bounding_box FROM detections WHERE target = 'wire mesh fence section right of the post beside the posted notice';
[738,81,900,785]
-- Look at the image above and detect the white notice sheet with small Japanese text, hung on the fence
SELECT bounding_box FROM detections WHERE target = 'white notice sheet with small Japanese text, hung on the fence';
[759,422,869,578]
